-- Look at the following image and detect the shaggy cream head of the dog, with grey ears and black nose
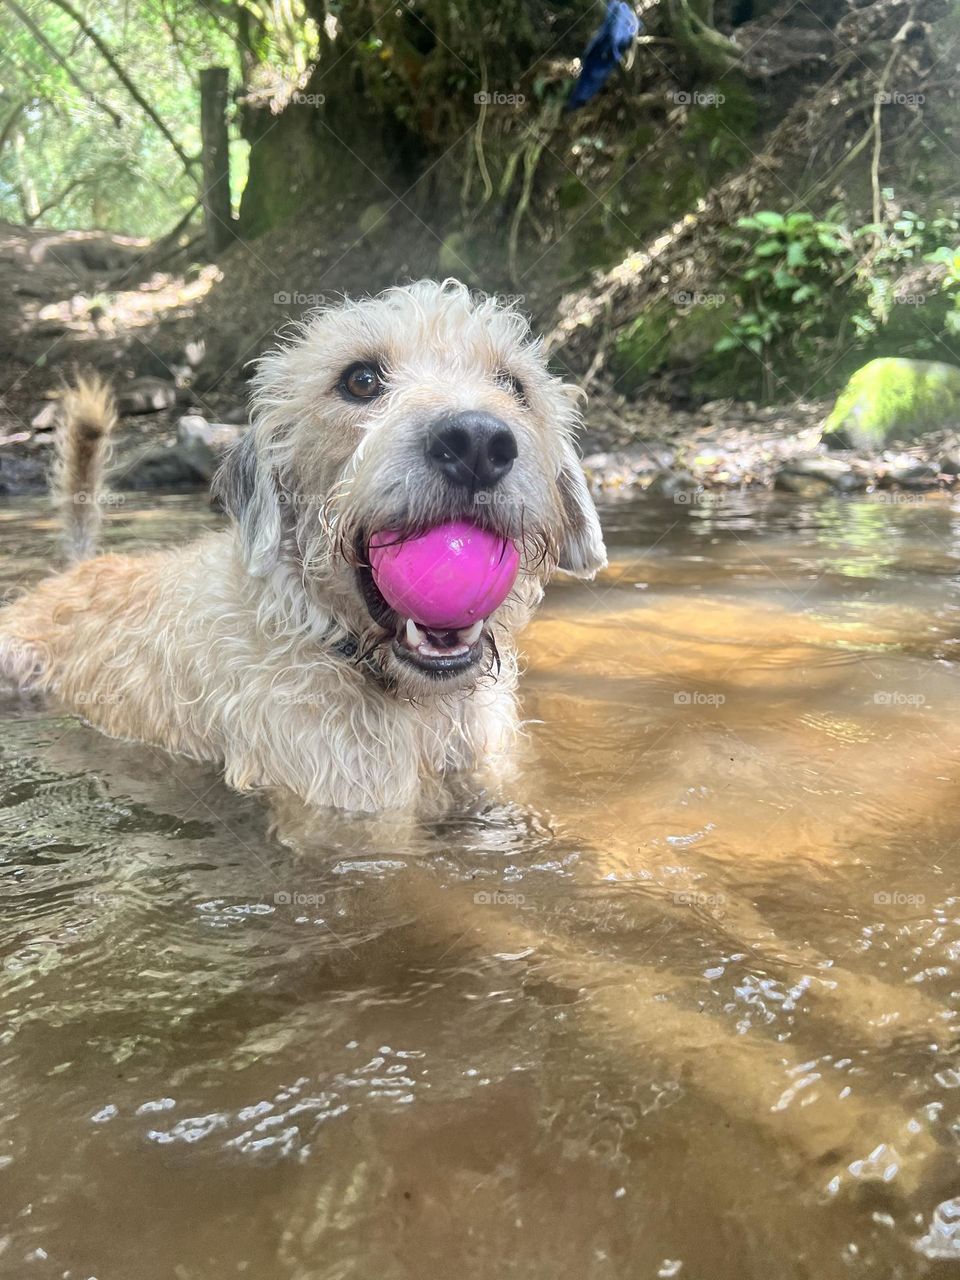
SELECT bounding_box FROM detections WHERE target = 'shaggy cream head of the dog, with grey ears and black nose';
[218,282,605,698]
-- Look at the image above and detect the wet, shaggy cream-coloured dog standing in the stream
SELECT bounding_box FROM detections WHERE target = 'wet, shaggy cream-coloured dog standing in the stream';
[0,280,607,813]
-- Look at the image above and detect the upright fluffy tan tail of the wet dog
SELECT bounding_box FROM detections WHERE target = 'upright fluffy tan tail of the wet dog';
[52,374,116,563]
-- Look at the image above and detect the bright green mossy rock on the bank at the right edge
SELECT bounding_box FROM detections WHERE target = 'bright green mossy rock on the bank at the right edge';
[823,358,960,451]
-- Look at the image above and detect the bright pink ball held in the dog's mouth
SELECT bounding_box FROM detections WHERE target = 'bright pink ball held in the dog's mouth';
[367,520,520,631]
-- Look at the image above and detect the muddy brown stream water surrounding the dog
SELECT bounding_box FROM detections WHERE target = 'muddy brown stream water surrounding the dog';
[0,483,960,1280]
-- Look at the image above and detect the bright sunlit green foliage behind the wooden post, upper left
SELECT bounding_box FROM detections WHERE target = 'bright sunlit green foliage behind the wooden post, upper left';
[0,0,315,236]
